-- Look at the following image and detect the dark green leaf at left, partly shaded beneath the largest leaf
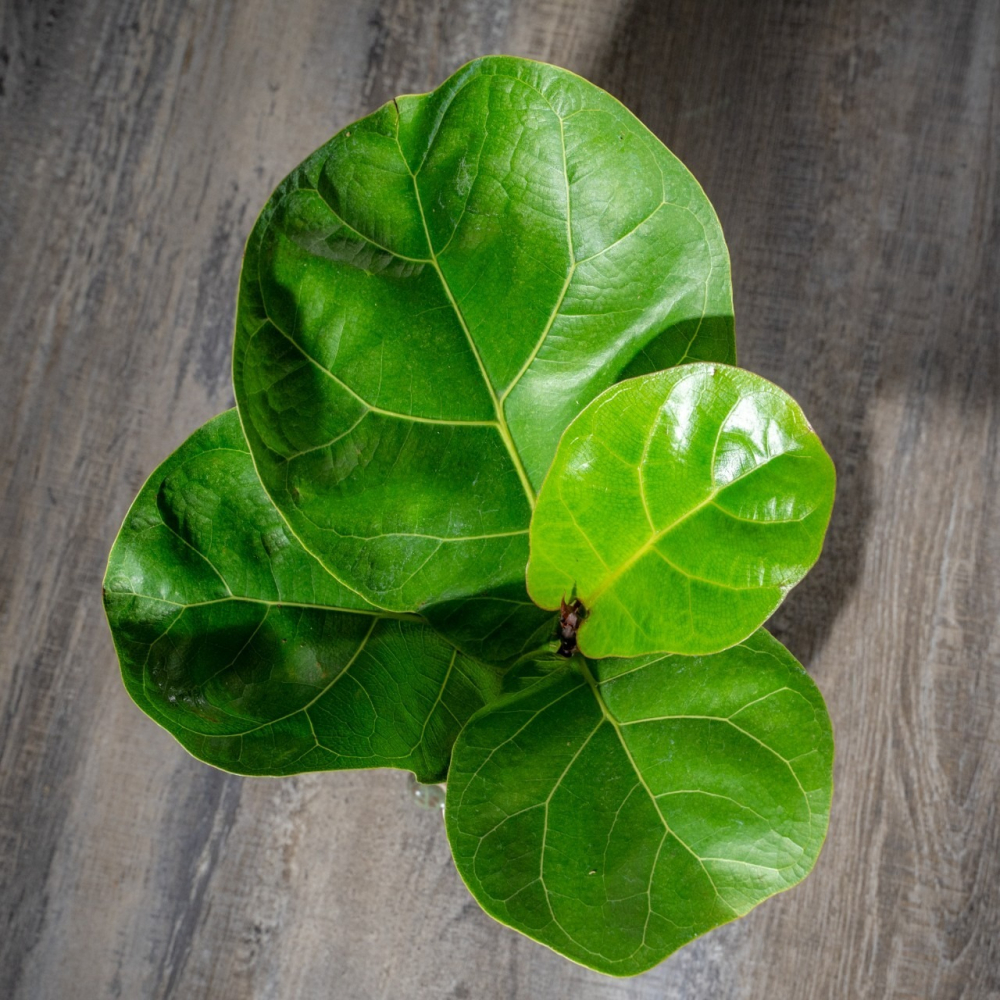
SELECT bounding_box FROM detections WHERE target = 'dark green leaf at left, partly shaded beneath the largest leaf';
[105,410,499,781]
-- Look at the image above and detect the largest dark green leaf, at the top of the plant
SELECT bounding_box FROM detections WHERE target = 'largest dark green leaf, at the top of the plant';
[233,57,735,611]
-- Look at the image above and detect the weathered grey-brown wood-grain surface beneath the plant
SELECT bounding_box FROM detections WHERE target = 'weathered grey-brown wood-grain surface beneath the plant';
[0,0,1000,1000]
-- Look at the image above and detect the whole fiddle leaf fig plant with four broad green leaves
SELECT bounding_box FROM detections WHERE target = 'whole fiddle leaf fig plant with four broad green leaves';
[104,56,834,975]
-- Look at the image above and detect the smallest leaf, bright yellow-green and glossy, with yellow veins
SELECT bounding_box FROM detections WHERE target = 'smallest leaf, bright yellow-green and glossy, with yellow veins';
[528,363,835,657]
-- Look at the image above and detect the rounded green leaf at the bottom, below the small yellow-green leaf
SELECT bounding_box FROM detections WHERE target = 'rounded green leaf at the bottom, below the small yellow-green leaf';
[445,630,833,976]
